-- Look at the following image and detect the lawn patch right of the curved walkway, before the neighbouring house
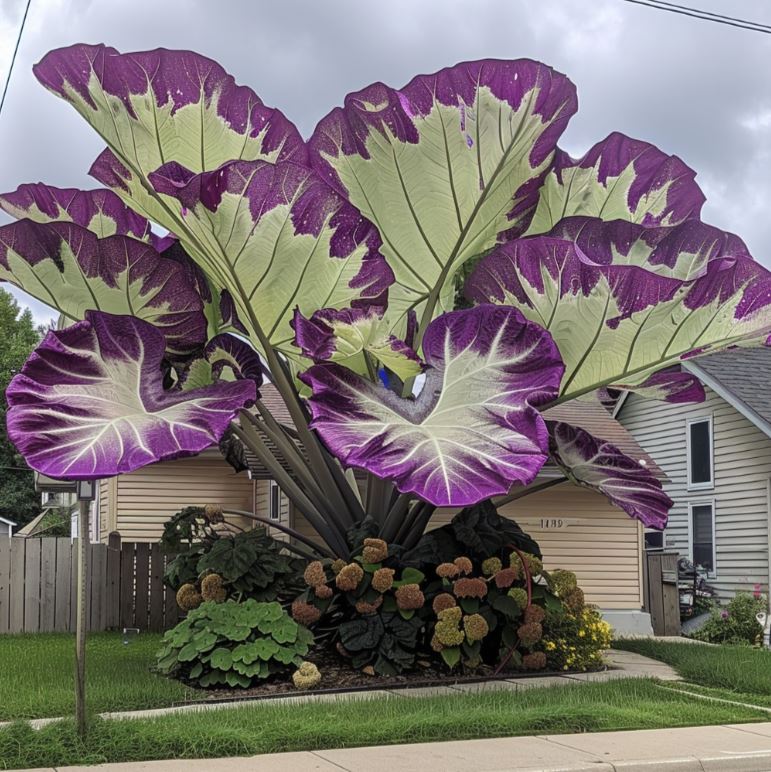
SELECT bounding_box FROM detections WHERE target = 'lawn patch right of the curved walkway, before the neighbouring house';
[613,639,771,704]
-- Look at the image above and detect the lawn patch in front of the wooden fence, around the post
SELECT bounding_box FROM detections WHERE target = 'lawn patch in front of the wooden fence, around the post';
[0,633,202,721]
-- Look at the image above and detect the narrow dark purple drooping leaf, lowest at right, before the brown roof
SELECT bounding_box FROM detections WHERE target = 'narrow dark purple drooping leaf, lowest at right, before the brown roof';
[546,421,673,529]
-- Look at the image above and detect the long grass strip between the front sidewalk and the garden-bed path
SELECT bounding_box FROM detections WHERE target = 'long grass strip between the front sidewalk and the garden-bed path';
[0,679,768,768]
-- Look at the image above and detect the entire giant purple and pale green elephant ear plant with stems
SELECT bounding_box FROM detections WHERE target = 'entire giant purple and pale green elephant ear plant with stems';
[0,45,771,557]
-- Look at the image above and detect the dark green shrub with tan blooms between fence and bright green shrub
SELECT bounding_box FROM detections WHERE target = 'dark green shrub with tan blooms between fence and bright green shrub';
[161,507,305,605]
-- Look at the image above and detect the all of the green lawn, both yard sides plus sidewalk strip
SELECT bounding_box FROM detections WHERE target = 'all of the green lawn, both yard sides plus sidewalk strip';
[0,633,771,769]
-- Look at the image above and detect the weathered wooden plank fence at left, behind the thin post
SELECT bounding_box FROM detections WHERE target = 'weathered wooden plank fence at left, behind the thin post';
[0,533,180,634]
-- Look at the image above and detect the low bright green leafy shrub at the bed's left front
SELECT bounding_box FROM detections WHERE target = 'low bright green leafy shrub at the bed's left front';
[157,598,313,688]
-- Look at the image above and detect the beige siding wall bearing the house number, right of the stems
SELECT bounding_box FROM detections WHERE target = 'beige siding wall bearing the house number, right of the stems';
[294,483,642,610]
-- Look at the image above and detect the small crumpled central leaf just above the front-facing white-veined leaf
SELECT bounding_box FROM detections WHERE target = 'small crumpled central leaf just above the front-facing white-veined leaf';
[292,306,422,381]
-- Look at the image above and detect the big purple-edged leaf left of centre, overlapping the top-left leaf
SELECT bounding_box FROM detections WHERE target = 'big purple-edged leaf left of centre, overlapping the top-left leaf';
[150,161,393,356]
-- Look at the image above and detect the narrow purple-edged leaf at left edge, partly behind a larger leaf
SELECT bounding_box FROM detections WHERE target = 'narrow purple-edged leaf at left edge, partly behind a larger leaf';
[0,182,150,241]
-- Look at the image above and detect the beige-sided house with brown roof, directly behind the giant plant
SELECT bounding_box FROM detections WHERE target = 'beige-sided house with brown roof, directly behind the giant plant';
[94,384,660,634]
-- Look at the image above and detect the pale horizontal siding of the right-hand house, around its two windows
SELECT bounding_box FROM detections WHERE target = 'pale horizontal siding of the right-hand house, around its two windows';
[618,388,771,600]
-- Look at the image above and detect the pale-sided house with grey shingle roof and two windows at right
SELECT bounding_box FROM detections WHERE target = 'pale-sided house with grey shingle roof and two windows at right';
[615,348,771,601]
